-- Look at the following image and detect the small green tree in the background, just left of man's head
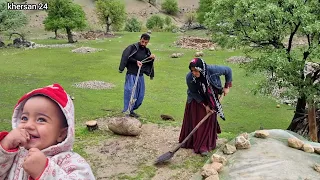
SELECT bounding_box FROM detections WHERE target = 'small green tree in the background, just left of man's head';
[96,0,126,33]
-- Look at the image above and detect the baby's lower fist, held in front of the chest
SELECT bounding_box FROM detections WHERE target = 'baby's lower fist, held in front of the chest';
[22,148,47,179]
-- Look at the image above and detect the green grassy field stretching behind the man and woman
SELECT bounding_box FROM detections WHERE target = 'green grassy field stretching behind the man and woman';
[0,30,293,177]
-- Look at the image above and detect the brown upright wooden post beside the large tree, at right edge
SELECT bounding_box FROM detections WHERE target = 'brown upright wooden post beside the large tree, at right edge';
[308,102,318,142]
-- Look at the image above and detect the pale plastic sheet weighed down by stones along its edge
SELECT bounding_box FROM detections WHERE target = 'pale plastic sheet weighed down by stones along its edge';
[196,129,320,180]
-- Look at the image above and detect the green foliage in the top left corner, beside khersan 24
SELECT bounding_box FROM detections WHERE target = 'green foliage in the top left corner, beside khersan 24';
[0,0,27,32]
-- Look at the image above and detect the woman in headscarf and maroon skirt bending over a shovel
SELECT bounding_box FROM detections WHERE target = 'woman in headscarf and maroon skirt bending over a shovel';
[179,58,232,156]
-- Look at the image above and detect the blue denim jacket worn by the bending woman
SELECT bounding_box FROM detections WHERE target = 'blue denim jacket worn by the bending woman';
[186,65,232,103]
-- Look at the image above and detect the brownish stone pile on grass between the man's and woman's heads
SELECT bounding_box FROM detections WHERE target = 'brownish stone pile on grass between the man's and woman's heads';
[174,36,216,50]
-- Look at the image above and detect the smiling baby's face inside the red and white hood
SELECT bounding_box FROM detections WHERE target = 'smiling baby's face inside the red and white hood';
[18,96,65,150]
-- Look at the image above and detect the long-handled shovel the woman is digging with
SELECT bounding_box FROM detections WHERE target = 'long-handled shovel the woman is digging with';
[155,112,213,164]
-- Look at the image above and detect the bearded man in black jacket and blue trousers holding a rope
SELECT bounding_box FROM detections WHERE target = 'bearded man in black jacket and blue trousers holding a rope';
[119,34,155,118]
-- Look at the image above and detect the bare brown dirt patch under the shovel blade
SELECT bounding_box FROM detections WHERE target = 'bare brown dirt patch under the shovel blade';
[86,120,205,180]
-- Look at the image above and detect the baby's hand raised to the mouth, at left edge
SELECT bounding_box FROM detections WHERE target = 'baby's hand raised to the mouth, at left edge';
[1,128,30,150]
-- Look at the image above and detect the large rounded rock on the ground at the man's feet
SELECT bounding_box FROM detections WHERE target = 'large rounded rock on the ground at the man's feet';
[108,117,142,136]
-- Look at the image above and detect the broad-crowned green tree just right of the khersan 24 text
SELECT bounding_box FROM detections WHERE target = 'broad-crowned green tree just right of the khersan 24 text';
[44,0,87,43]
